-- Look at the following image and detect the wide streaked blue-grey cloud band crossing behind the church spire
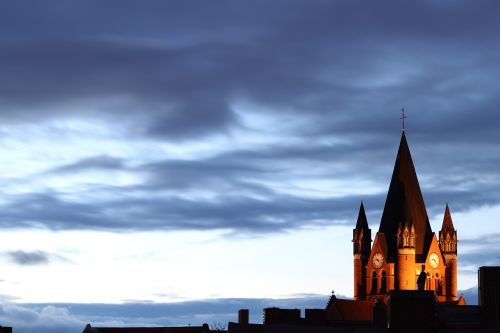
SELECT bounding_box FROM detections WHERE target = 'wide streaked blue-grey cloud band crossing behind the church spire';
[0,140,500,234]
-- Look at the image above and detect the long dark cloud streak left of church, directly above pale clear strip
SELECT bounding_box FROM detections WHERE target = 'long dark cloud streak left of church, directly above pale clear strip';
[0,188,368,233]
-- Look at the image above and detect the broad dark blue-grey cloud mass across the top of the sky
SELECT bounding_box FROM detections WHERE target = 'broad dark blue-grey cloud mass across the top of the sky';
[0,1,499,139]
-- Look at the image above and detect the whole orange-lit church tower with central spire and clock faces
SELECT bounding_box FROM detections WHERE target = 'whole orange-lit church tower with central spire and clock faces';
[353,132,458,303]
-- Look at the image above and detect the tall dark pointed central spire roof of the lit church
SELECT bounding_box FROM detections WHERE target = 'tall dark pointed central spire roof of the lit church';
[379,132,432,260]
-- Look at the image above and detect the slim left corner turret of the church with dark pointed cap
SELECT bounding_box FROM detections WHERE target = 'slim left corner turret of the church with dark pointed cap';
[352,202,372,301]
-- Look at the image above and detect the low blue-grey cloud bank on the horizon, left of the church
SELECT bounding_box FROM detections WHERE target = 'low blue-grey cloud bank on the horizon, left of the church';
[0,295,328,333]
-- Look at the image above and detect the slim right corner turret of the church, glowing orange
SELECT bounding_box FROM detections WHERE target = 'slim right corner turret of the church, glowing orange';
[439,204,458,301]
